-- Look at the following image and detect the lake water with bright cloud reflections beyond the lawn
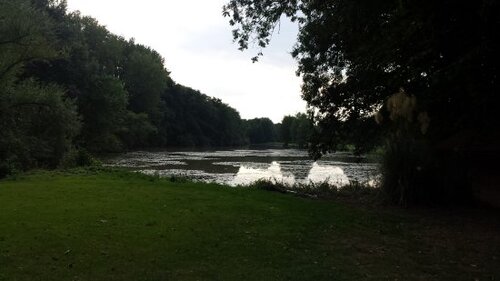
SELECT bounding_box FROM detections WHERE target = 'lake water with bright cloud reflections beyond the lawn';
[104,149,378,186]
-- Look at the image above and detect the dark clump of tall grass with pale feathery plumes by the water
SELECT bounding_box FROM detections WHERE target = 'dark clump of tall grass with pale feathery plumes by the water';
[376,90,467,206]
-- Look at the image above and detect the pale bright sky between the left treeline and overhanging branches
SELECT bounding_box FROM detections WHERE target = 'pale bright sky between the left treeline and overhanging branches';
[68,0,306,123]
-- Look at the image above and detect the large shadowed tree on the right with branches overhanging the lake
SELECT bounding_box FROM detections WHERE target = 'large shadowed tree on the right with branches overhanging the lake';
[223,0,500,202]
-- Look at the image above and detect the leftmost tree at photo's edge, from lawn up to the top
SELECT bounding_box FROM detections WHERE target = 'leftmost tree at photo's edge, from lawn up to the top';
[0,0,80,177]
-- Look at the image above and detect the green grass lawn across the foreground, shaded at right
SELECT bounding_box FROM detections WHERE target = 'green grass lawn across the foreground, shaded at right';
[0,167,500,281]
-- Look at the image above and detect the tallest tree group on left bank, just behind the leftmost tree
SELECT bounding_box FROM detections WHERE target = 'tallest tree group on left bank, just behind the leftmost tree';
[23,7,169,151]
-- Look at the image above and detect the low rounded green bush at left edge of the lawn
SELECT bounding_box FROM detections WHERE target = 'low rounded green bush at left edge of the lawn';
[0,80,80,176]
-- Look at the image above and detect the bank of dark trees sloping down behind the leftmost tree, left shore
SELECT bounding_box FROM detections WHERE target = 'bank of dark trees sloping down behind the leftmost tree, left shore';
[21,0,252,152]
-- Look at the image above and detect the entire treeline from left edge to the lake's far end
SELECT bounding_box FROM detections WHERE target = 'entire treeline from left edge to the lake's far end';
[0,0,312,176]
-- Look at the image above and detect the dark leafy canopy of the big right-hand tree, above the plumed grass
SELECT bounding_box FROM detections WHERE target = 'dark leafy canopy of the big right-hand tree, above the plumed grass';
[224,0,499,144]
